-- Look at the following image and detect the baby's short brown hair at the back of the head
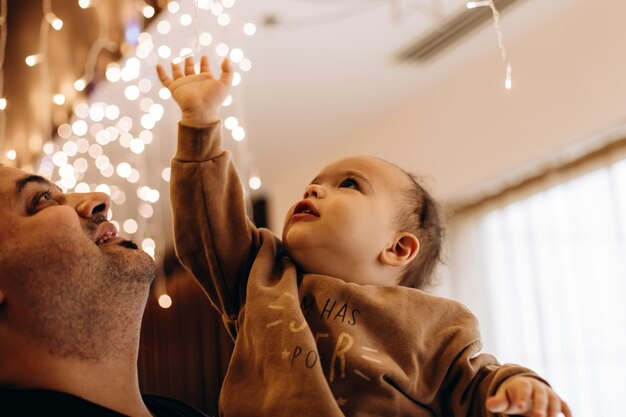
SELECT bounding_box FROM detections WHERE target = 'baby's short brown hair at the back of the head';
[397,167,444,289]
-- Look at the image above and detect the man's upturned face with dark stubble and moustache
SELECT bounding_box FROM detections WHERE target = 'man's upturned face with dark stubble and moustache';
[0,166,155,354]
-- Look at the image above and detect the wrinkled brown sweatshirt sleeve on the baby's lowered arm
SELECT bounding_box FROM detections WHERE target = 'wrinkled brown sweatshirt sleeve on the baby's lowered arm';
[431,304,547,417]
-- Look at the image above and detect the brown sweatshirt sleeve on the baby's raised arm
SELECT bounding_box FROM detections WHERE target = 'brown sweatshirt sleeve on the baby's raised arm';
[170,122,259,336]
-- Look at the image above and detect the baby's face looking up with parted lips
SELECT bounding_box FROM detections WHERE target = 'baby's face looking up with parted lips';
[283,157,409,285]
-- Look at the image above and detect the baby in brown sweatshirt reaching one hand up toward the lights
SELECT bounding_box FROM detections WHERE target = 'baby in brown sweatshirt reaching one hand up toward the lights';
[157,57,571,417]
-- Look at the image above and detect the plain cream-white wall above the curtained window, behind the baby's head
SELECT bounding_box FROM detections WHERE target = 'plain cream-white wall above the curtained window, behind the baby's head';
[270,0,626,231]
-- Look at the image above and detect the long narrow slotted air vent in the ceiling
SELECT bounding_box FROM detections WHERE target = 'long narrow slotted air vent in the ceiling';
[398,0,519,61]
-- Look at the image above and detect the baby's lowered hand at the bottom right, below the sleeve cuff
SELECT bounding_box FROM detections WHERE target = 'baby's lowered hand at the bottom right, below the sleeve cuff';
[485,376,572,417]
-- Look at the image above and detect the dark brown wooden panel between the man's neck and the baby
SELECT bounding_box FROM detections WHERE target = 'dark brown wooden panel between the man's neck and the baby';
[138,269,233,415]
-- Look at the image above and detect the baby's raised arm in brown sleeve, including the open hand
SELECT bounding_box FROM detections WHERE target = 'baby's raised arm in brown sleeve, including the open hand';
[157,56,259,334]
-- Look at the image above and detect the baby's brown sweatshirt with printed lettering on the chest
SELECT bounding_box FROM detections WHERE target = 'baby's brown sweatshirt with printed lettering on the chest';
[171,123,535,417]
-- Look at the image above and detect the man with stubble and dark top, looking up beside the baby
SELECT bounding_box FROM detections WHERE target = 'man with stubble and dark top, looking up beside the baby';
[0,165,203,416]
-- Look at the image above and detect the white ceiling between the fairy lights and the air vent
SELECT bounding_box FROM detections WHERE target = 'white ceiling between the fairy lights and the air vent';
[237,0,488,185]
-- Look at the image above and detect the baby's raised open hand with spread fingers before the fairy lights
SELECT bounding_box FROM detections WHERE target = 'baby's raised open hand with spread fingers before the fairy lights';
[156,56,233,127]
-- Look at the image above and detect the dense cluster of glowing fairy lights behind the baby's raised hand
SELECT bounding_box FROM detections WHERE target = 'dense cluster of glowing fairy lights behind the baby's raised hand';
[32,0,254,264]
